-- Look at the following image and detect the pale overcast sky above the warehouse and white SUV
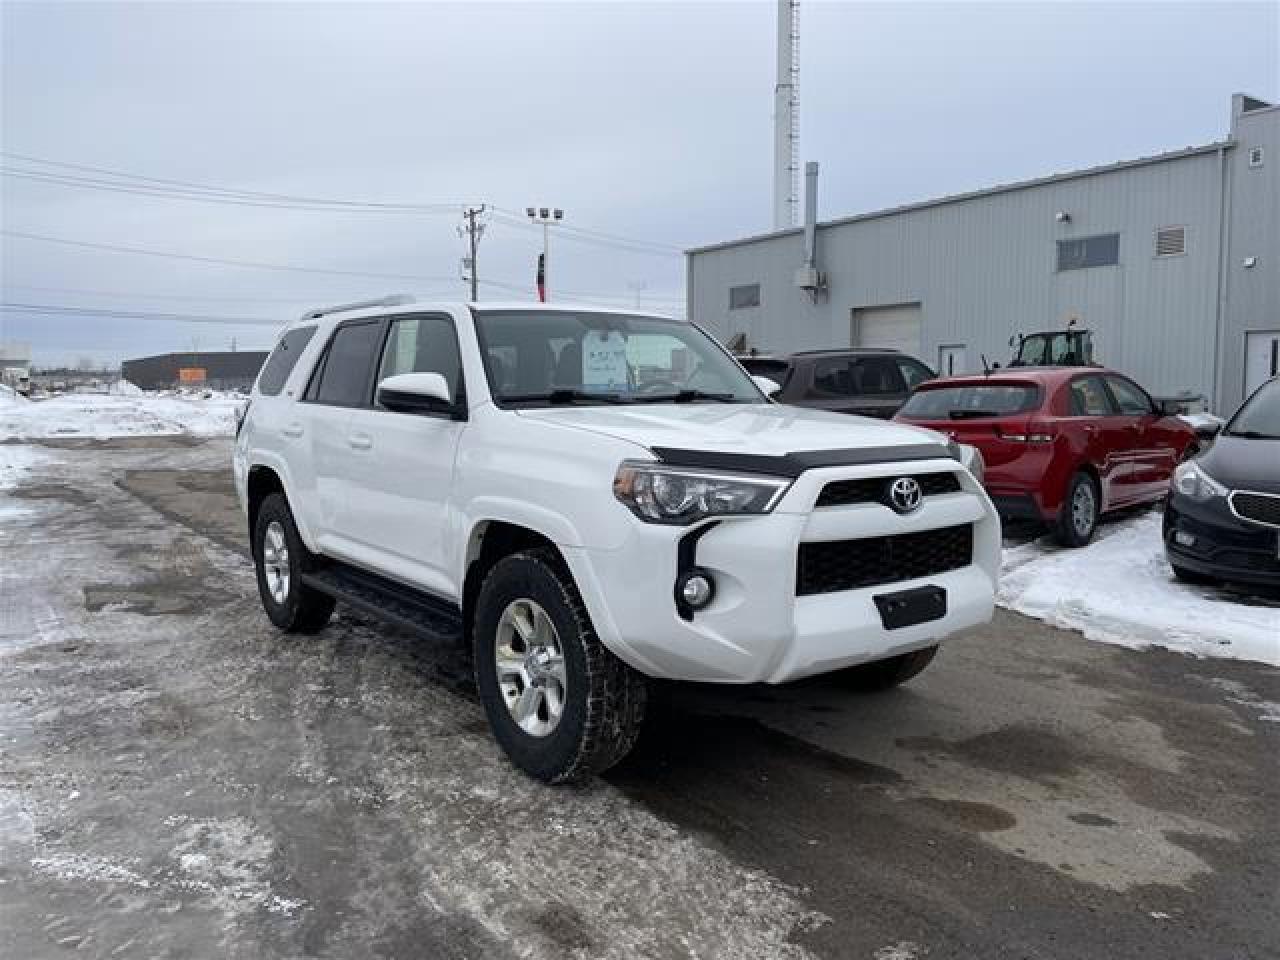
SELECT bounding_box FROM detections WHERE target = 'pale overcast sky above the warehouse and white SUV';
[0,1,1280,364]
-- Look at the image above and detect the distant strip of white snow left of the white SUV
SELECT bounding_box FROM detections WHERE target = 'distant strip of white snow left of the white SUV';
[0,384,244,442]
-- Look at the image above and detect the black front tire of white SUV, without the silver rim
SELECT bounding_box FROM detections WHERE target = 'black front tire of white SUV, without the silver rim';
[471,548,646,783]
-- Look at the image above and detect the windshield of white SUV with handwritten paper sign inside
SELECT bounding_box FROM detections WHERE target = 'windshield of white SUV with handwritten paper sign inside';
[475,310,765,406]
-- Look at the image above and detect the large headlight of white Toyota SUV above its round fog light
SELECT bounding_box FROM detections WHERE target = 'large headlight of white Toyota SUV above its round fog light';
[613,461,791,526]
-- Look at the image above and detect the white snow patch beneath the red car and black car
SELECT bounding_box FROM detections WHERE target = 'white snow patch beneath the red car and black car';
[1000,512,1280,666]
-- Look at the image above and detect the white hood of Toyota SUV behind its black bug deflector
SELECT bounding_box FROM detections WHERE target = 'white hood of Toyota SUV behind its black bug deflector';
[520,403,947,457]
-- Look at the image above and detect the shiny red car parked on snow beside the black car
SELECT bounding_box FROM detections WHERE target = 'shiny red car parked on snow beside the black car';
[895,366,1197,547]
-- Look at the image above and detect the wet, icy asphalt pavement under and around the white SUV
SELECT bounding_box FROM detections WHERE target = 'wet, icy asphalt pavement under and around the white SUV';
[0,439,1280,960]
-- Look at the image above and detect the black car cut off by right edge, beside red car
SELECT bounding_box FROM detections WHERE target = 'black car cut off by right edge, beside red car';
[1165,379,1280,588]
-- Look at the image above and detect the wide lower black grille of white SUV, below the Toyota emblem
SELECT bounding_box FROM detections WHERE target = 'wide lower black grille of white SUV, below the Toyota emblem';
[796,524,973,596]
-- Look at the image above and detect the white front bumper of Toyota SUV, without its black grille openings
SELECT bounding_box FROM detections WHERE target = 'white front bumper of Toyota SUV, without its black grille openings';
[562,460,1001,684]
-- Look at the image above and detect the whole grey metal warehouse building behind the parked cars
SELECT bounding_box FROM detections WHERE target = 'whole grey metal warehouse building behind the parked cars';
[687,93,1280,412]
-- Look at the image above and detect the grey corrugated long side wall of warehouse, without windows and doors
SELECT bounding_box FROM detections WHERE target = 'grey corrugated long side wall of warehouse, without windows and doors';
[689,151,1221,407]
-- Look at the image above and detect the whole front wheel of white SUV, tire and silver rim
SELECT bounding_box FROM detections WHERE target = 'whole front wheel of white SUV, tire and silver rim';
[472,549,645,783]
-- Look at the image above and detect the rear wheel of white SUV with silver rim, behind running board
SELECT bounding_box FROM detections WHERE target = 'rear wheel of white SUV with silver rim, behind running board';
[253,493,334,634]
